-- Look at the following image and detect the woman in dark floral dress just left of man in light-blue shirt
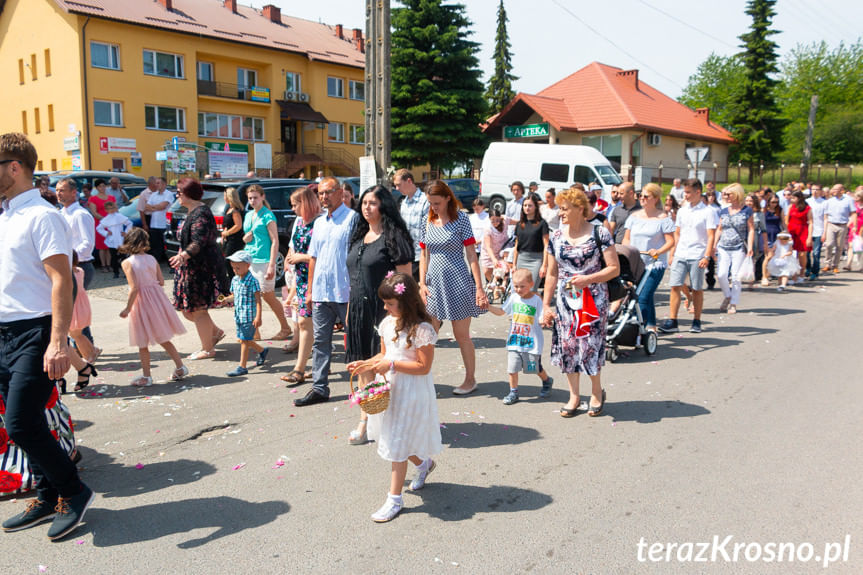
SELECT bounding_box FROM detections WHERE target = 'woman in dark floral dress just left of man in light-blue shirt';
[282,184,321,385]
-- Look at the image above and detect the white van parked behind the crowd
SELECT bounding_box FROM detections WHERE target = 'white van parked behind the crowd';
[479,142,623,212]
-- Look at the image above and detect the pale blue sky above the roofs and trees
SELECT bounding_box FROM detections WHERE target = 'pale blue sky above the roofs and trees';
[272,0,863,98]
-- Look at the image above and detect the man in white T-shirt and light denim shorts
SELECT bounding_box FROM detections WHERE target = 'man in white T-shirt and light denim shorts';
[659,178,719,333]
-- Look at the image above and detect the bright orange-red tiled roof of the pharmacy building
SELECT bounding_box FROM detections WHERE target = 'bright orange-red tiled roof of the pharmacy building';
[488,62,734,144]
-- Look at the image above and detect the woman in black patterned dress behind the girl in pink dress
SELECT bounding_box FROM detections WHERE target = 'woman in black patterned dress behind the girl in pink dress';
[170,178,225,359]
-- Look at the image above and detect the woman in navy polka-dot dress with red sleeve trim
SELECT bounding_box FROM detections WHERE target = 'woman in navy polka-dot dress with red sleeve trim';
[419,180,488,395]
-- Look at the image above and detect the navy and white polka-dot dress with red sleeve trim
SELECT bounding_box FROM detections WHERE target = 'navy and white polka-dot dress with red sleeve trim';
[420,212,485,321]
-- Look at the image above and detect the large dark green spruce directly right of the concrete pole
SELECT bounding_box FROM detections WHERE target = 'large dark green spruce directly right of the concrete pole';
[391,0,488,170]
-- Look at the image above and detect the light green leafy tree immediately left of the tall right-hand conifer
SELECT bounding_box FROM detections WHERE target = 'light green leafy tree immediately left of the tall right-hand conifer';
[678,53,743,130]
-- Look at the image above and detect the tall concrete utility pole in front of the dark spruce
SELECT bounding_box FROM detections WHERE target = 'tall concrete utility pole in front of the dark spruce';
[365,0,391,182]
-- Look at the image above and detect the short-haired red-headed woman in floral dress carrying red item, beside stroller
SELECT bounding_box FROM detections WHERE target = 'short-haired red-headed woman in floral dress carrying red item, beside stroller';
[543,188,620,417]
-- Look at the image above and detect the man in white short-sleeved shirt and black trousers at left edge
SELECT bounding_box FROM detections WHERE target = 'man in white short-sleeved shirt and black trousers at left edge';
[0,133,94,540]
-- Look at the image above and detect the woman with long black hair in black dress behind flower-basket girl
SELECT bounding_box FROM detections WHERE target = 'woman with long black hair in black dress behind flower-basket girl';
[346,186,414,444]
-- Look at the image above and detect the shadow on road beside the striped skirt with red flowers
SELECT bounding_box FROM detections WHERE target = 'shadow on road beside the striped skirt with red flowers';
[79,446,216,497]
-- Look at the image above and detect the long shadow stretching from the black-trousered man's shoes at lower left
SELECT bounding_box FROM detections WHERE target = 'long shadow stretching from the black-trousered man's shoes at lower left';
[76,496,291,548]
